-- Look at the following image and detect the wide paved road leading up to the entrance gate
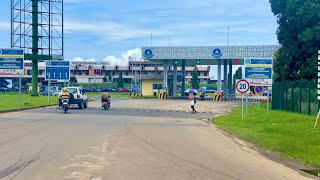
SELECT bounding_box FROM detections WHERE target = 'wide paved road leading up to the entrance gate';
[0,99,316,180]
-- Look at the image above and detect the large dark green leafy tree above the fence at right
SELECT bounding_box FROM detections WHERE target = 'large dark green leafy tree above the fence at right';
[269,0,320,81]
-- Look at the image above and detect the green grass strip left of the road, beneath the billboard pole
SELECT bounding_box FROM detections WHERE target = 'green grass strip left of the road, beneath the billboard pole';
[0,94,58,112]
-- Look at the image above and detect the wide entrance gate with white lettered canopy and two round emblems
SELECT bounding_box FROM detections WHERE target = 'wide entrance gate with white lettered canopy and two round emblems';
[141,45,281,98]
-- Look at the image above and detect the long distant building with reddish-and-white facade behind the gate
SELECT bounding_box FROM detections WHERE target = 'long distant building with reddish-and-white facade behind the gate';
[0,61,210,83]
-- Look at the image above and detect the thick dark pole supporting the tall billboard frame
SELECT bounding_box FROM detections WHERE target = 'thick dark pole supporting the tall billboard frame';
[31,0,39,96]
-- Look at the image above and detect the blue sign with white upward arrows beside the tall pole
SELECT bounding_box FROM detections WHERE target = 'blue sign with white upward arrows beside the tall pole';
[46,61,70,81]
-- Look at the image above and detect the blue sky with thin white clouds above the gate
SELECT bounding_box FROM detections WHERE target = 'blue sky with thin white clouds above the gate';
[0,0,278,67]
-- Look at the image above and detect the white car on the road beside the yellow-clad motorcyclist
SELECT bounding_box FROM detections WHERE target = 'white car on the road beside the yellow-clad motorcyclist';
[59,87,88,109]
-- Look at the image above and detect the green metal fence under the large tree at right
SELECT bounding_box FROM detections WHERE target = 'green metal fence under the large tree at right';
[272,82,320,115]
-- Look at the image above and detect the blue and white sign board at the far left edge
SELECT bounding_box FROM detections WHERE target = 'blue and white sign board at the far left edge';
[0,49,24,75]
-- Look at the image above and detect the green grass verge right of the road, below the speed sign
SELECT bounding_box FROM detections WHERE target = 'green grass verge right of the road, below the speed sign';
[213,105,320,167]
